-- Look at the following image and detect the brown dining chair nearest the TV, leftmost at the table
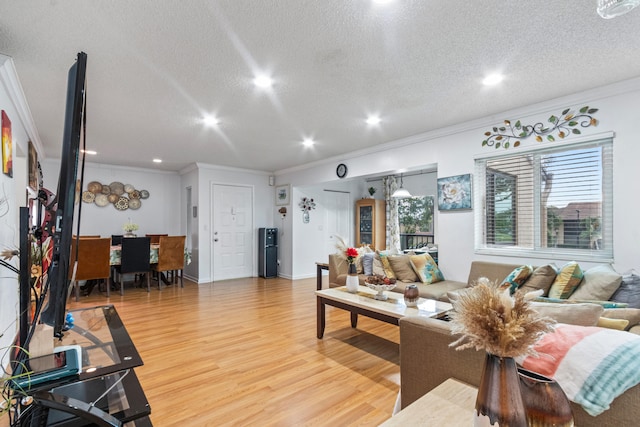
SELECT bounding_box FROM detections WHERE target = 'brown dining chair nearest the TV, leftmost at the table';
[69,237,111,301]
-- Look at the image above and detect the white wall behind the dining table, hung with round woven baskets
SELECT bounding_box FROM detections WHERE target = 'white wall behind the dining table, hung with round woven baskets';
[42,159,184,237]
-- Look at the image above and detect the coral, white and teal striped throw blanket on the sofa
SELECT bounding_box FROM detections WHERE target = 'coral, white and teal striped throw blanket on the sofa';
[517,324,640,416]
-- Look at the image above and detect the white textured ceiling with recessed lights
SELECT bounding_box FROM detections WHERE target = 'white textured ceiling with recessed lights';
[0,0,640,172]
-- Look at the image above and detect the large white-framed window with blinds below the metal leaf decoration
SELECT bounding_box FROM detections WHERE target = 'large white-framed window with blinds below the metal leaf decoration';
[474,138,613,260]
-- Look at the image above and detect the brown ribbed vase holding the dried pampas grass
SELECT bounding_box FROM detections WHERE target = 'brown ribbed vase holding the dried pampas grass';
[474,354,527,427]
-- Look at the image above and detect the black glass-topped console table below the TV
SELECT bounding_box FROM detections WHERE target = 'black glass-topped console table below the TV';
[24,305,151,427]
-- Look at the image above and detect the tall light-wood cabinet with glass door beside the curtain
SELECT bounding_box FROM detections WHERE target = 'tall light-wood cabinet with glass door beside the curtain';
[356,199,387,250]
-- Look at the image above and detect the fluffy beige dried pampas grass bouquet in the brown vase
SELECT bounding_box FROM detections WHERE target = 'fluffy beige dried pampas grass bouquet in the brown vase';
[450,280,555,357]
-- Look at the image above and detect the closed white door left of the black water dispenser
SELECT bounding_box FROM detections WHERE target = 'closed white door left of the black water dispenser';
[211,184,255,281]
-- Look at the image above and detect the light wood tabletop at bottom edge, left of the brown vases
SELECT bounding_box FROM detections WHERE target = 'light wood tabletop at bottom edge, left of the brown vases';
[380,378,478,427]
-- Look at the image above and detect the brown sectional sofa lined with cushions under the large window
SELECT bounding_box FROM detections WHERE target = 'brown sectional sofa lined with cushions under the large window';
[329,255,640,427]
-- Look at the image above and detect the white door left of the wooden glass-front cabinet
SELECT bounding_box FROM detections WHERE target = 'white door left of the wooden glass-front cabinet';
[323,190,353,259]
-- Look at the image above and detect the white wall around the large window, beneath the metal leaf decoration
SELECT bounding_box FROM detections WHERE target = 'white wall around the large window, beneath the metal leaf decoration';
[276,79,640,281]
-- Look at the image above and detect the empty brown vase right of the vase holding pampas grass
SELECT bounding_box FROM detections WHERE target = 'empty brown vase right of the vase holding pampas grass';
[518,368,573,427]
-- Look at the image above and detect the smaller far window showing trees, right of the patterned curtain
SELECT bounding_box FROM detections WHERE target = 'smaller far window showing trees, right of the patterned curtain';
[398,196,434,250]
